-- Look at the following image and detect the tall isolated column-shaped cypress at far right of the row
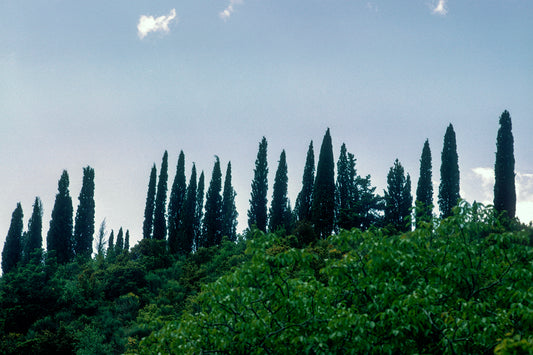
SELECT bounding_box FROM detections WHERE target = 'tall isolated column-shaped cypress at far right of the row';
[494,110,516,218]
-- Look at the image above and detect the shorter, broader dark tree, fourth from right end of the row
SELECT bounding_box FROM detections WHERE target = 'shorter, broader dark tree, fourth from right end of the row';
[385,159,413,232]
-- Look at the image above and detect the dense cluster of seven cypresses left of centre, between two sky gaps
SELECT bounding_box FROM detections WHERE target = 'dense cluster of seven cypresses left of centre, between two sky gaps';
[143,151,238,255]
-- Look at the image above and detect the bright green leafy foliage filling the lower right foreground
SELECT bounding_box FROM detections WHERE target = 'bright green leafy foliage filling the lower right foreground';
[138,202,533,354]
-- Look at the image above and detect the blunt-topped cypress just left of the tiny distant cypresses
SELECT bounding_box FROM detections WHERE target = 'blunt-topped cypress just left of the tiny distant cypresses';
[74,166,95,258]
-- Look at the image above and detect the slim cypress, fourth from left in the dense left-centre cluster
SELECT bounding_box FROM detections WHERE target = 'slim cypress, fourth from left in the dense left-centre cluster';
[175,164,197,255]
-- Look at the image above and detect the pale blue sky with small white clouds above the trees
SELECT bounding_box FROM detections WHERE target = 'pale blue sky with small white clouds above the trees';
[0,0,533,258]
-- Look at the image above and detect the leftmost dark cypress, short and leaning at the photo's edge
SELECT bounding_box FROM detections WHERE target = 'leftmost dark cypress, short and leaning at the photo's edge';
[2,202,24,275]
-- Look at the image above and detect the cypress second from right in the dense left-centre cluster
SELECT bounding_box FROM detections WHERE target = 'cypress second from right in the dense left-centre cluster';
[200,157,222,247]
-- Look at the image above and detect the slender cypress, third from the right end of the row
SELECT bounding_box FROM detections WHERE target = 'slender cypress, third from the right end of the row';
[415,139,433,226]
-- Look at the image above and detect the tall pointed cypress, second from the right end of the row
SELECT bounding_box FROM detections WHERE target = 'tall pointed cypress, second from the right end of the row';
[439,123,460,218]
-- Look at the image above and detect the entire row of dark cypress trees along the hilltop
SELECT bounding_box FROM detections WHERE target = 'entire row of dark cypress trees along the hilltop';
[2,110,516,273]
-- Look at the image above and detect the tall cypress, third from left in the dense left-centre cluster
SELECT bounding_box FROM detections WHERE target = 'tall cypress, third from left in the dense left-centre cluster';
[168,151,187,254]
